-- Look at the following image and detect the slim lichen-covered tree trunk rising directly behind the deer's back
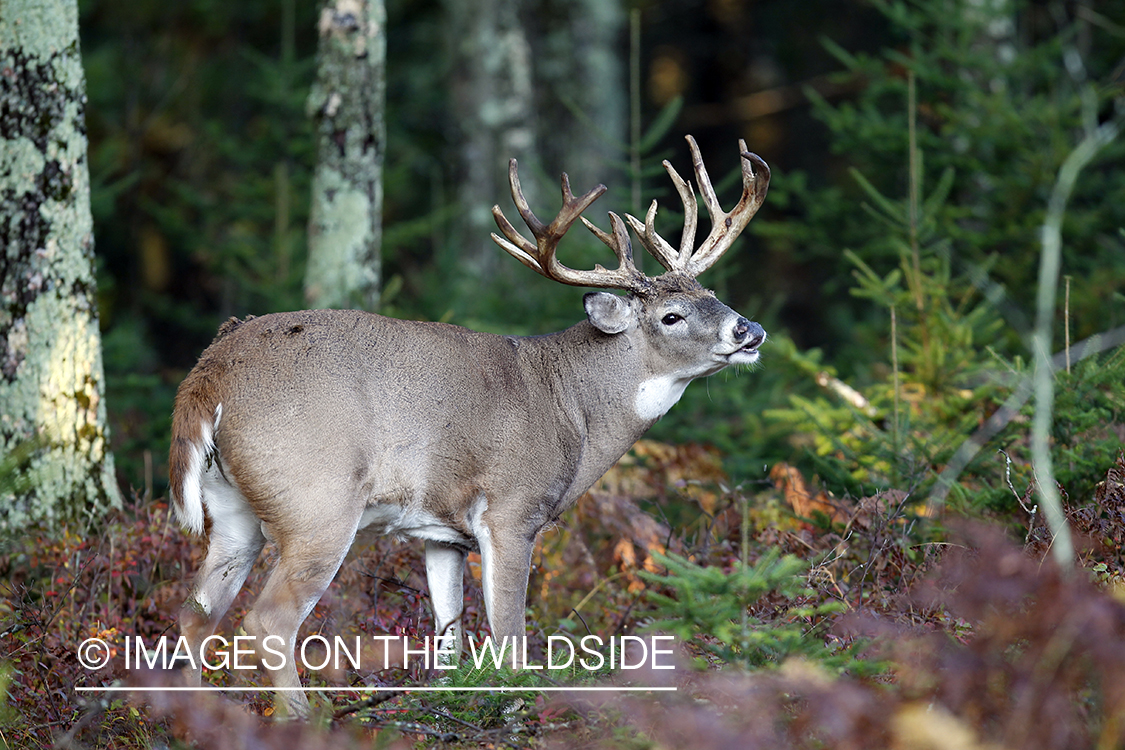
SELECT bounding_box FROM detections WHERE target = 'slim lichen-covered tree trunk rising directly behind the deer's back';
[305,0,387,310]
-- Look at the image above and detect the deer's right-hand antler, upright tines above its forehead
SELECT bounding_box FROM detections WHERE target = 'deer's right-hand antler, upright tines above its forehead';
[625,136,770,278]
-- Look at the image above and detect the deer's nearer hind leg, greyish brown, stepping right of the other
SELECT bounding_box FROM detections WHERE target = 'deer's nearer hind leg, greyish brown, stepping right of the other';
[243,510,359,716]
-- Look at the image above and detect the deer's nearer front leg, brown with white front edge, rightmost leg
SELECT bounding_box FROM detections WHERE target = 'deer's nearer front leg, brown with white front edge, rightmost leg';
[477,516,536,657]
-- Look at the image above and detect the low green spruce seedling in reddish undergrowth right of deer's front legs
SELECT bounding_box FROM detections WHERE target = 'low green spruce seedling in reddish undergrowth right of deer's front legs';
[640,550,863,670]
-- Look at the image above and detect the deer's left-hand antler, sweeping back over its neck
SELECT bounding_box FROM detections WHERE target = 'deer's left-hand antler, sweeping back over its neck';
[492,159,648,291]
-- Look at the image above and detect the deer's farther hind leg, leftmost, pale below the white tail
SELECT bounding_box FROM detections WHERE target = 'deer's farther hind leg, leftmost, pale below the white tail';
[179,472,266,685]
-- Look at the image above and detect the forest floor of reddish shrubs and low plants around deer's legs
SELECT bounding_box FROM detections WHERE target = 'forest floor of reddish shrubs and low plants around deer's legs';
[0,441,1125,750]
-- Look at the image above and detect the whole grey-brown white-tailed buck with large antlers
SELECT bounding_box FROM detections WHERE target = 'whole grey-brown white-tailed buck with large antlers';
[169,136,770,716]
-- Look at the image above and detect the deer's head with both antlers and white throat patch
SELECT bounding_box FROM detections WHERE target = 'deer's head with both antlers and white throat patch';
[492,136,770,418]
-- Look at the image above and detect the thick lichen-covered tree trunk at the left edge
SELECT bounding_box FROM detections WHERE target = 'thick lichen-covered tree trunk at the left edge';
[0,0,120,531]
